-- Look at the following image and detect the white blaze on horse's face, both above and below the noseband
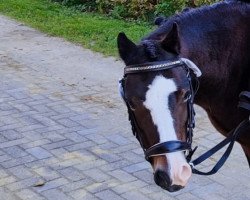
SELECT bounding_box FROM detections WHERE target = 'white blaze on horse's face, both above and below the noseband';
[144,76,190,185]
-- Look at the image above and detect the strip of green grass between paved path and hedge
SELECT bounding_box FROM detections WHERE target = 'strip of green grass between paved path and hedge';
[0,0,152,56]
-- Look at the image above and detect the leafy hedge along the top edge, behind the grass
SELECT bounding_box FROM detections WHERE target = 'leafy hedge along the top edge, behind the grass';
[53,0,218,20]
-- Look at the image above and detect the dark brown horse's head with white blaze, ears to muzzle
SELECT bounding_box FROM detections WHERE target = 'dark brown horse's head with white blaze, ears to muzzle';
[118,24,200,192]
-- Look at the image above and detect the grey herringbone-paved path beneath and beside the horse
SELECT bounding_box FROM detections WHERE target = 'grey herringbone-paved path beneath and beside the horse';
[0,16,250,200]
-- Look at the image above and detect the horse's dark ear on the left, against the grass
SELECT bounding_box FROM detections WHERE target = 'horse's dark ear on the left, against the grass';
[117,33,137,63]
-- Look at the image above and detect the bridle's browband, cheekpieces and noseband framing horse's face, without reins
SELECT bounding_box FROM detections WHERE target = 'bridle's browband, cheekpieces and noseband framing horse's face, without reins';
[120,60,198,162]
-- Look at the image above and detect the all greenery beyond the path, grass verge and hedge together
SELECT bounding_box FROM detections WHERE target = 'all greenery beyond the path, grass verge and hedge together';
[0,0,221,56]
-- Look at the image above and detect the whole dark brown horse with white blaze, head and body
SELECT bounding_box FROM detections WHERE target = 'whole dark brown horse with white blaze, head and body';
[117,0,250,192]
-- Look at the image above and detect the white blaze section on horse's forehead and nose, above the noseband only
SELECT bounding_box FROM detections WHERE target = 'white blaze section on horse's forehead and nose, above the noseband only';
[144,76,177,142]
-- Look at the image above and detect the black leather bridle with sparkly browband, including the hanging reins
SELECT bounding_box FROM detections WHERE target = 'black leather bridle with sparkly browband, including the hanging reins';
[119,59,249,175]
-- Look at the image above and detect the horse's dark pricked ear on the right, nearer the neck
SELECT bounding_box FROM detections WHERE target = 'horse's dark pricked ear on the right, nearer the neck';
[161,22,180,54]
